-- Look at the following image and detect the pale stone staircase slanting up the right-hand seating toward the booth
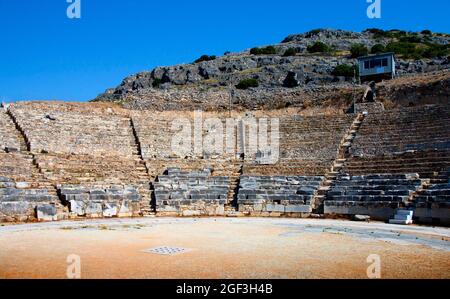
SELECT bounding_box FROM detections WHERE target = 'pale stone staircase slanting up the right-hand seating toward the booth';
[312,114,365,214]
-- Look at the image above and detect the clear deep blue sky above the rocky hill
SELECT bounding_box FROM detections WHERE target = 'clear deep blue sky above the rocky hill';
[0,0,450,101]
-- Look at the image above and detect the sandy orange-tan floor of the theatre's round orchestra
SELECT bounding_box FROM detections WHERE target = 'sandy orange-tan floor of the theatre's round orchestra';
[0,218,450,279]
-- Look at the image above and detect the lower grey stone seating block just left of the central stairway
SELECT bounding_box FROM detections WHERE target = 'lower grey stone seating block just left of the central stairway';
[154,168,230,216]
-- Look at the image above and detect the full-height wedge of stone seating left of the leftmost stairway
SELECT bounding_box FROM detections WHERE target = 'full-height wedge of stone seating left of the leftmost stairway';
[0,111,63,221]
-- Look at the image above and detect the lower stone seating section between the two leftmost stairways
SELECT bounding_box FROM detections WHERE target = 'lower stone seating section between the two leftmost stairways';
[36,154,151,217]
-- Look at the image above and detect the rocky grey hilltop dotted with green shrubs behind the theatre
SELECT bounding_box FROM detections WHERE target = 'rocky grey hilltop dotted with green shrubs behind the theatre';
[93,29,450,110]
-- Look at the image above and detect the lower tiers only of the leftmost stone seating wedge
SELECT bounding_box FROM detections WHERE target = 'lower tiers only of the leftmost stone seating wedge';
[0,152,62,222]
